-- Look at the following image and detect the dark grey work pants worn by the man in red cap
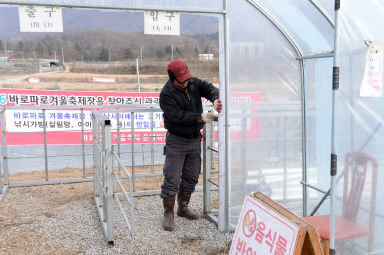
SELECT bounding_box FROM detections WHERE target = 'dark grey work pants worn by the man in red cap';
[160,132,201,198]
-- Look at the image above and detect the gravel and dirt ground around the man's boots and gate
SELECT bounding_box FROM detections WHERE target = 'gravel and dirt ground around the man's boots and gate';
[0,183,233,255]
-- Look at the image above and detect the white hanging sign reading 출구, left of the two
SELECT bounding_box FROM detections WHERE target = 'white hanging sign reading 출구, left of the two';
[19,5,63,32]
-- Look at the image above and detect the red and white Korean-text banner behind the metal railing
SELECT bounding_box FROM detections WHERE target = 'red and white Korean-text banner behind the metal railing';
[0,89,166,145]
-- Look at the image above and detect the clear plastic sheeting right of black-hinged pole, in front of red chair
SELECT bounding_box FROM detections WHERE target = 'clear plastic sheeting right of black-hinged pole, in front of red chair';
[335,0,384,255]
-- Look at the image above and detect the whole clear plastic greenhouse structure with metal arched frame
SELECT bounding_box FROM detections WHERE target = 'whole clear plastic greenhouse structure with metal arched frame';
[0,0,384,254]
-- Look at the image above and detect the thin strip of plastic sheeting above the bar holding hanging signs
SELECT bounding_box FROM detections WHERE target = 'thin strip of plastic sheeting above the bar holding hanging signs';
[0,0,223,12]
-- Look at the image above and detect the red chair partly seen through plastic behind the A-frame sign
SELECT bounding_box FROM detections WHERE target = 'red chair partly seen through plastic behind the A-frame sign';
[304,152,377,255]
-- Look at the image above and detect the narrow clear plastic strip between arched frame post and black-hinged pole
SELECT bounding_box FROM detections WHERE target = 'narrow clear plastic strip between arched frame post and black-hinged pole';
[305,57,333,215]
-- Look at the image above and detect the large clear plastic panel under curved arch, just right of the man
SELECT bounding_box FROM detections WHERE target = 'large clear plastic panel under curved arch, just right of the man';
[228,1,303,229]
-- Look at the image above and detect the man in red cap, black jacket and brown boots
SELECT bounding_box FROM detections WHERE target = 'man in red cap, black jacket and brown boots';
[160,59,223,231]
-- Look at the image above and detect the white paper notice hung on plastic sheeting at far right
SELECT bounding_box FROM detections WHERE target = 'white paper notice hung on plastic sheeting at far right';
[360,45,384,97]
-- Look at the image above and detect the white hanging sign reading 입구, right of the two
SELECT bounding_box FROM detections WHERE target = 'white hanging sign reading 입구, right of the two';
[144,11,180,35]
